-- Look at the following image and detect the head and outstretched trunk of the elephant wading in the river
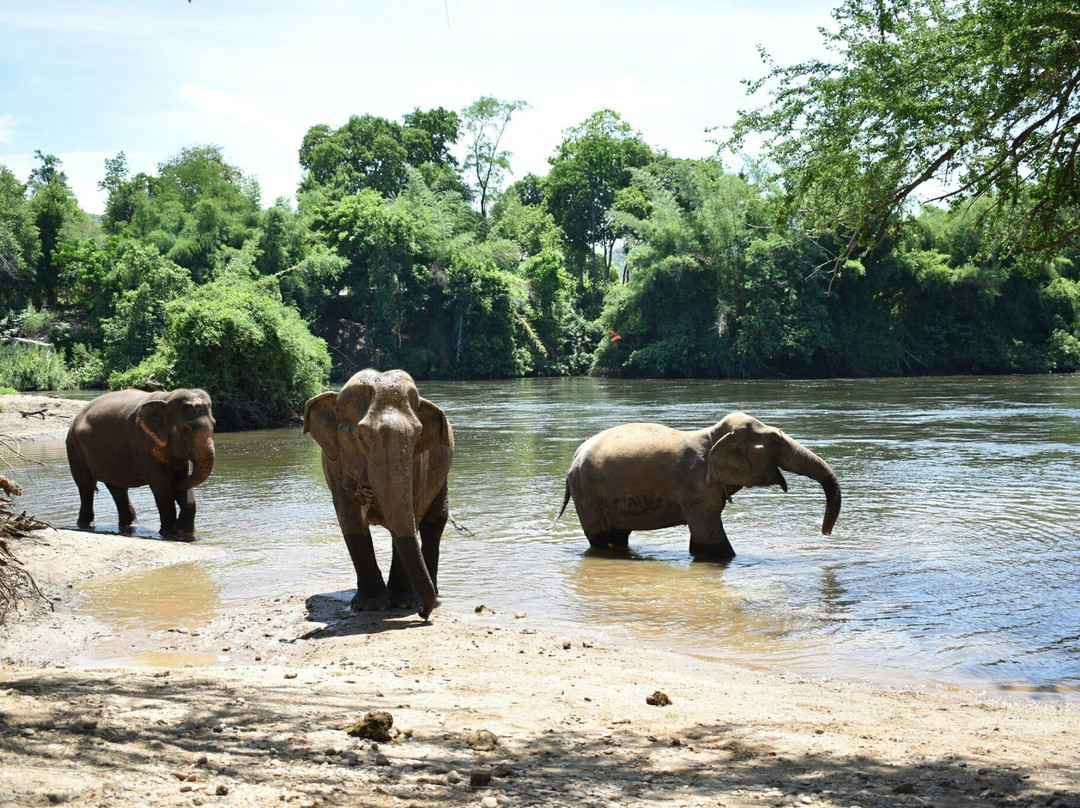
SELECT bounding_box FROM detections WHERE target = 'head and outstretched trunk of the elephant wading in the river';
[705,413,840,536]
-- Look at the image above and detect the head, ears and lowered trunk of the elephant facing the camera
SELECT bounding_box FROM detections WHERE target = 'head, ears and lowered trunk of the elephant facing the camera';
[303,368,454,618]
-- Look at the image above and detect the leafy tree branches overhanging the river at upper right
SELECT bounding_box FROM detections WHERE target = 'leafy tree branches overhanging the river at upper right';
[726,0,1080,270]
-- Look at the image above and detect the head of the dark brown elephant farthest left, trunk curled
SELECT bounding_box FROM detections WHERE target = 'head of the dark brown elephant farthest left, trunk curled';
[135,389,214,491]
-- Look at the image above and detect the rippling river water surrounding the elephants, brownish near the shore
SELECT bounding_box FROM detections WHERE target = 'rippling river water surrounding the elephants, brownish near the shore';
[10,376,1080,691]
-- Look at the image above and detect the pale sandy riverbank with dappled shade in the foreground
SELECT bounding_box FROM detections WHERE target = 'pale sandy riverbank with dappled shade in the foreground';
[0,530,1080,807]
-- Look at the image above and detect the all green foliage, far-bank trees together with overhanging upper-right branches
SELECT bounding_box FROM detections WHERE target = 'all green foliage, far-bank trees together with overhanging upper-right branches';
[0,22,1080,428]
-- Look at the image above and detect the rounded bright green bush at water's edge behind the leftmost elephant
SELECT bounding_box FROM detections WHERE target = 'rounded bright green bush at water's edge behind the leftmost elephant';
[109,278,330,429]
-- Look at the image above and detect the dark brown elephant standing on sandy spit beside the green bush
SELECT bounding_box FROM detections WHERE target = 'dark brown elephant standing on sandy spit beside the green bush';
[67,388,214,538]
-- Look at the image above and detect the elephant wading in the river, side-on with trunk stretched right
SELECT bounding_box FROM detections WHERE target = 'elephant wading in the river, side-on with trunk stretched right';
[555,413,840,561]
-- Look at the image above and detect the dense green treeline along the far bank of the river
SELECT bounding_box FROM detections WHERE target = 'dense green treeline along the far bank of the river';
[0,98,1080,427]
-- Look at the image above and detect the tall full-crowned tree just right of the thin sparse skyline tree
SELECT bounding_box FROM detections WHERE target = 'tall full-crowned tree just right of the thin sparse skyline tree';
[543,109,652,288]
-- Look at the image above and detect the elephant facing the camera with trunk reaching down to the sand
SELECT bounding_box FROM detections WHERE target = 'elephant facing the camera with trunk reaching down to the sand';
[303,368,454,620]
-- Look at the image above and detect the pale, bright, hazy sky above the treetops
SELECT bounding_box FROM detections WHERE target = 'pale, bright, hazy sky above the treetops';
[0,0,839,213]
